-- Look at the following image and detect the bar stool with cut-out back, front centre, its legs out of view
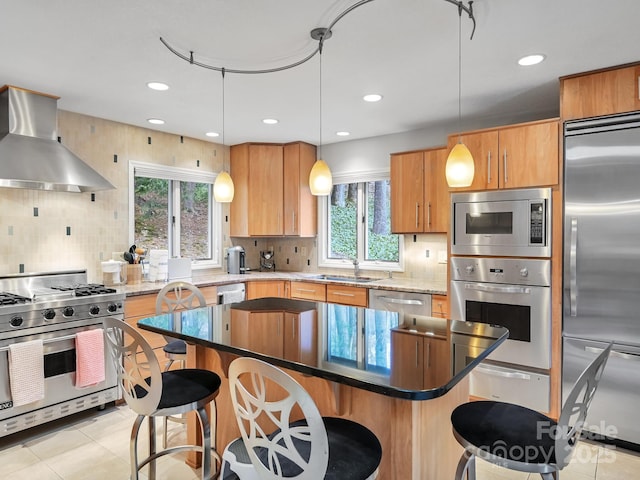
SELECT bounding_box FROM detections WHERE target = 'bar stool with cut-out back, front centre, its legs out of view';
[222,358,382,480]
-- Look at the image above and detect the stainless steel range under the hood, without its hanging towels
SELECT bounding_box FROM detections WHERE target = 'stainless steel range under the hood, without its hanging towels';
[0,270,125,437]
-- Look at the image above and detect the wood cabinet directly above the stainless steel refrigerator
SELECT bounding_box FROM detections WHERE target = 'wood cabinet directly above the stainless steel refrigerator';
[560,65,640,120]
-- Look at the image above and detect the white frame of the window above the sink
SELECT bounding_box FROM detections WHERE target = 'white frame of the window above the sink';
[318,170,404,272]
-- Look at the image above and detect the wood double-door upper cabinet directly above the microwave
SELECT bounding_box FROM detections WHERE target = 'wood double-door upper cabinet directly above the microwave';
[449,119,559,191]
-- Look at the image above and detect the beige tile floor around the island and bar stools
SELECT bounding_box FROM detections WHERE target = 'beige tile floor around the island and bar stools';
[0,405,640,480]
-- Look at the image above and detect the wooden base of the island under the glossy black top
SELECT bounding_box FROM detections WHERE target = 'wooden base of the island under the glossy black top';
[182,345,469,480]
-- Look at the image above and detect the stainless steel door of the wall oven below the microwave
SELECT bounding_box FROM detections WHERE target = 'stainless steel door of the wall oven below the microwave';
[450,281,551,369]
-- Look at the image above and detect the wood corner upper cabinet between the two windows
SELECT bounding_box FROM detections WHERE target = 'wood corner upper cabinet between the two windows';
[230,142,317,237]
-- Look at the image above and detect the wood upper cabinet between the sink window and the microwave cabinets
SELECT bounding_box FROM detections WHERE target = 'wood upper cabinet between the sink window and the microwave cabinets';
[390,148,449,233]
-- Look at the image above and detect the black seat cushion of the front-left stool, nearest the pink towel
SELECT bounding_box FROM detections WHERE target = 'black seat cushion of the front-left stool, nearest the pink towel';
[135,368,221,410]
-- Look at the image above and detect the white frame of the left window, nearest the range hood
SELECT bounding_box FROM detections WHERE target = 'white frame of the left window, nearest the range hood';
[129,160,223,270]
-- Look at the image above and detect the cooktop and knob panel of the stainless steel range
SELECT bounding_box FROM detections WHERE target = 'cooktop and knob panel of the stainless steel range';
[0,270,125,339]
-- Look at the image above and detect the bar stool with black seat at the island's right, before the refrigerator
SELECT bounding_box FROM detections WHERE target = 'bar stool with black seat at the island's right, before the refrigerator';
[451,344,612,480]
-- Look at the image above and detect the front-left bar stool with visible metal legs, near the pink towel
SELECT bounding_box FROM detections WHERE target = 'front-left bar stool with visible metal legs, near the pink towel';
[103,318,221,480]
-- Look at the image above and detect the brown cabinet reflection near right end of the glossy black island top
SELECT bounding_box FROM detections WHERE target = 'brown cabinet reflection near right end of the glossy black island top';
[391,330,451,389]
